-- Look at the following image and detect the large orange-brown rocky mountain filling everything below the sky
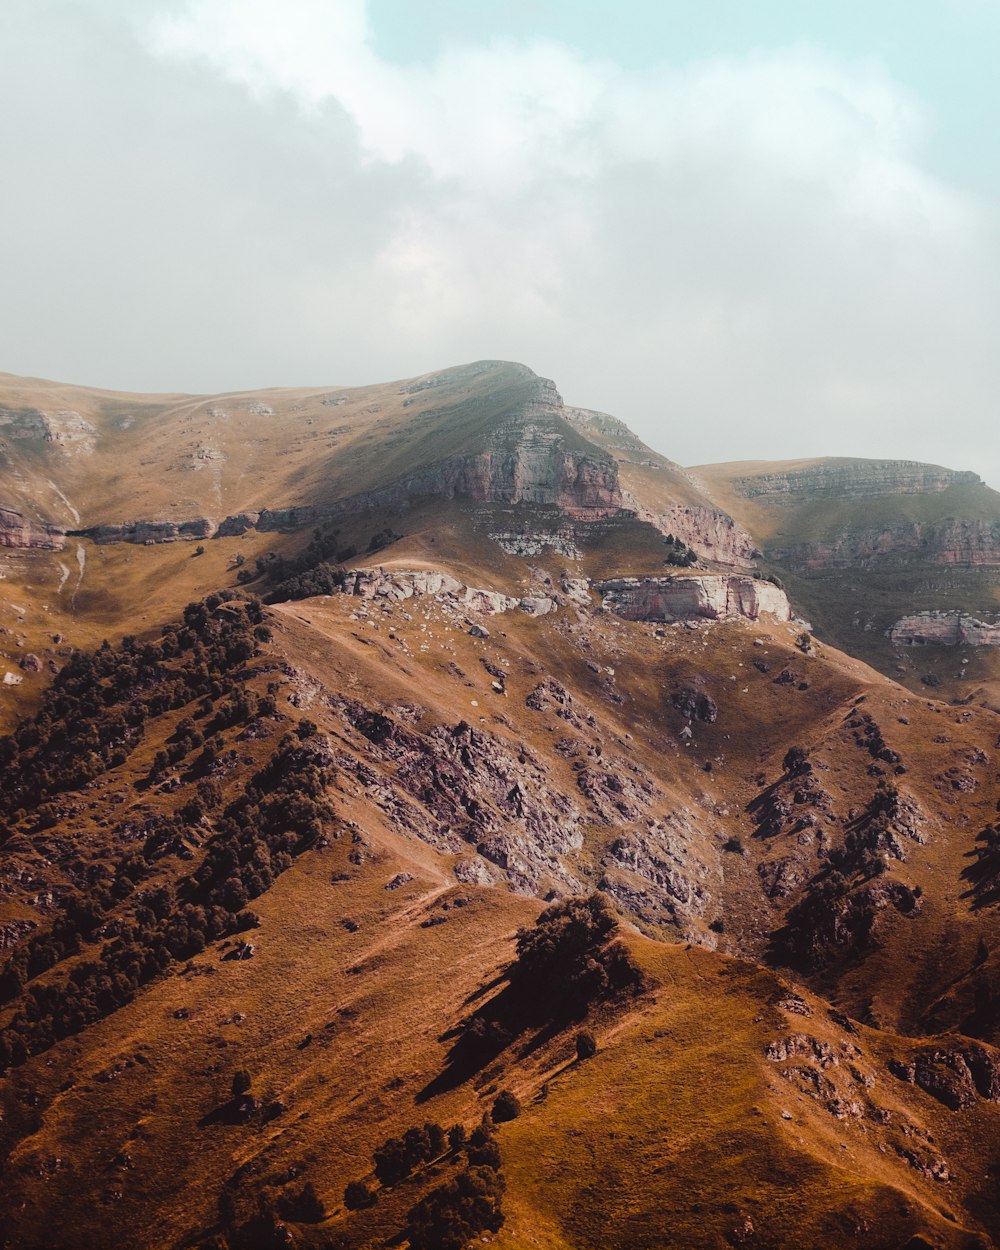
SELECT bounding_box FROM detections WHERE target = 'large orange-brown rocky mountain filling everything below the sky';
[0,363,1000,1250]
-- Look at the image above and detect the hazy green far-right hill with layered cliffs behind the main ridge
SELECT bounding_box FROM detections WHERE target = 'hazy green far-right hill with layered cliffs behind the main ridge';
[691,459,1000,706]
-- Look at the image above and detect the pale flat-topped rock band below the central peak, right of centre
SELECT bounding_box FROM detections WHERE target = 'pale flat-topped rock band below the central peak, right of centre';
[598,574,791,621]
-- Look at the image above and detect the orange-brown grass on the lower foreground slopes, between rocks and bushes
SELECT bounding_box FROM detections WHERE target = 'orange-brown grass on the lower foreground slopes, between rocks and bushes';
[1,572,996,1250]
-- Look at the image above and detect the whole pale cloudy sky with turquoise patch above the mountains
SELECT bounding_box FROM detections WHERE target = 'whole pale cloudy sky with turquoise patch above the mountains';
[0,0,1000,489]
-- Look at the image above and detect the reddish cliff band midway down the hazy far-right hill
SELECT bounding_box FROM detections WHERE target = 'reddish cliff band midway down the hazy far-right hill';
[768,519,1000,570]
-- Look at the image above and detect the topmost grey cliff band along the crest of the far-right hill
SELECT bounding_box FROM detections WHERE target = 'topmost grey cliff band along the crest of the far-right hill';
[734,460,981,499]
